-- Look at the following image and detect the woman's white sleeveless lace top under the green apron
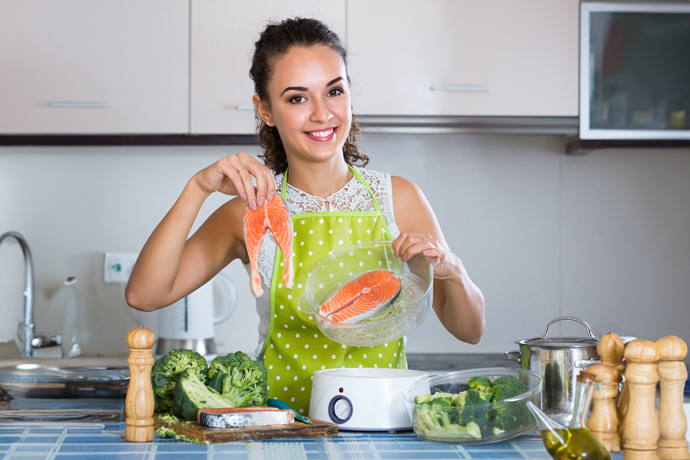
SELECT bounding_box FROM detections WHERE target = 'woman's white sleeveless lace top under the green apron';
[244,166,400,358]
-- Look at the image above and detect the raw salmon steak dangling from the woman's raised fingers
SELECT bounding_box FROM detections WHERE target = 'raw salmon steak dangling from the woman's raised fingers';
[244,196,295,297]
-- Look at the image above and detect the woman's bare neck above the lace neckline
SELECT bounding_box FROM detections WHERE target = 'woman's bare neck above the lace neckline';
[288,161,352,198]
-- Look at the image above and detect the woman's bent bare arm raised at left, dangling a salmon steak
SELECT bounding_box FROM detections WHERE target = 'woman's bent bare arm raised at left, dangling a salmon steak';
[125,153,275,311]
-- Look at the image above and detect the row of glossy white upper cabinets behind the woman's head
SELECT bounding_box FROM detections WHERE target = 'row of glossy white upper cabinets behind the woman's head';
[0,0,579,137]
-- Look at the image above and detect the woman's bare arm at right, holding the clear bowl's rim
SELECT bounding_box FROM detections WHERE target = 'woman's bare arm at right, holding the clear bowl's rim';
[391,176,485,344]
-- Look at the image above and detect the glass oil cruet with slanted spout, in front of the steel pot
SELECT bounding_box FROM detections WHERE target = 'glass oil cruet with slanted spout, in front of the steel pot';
[527,372,611,460]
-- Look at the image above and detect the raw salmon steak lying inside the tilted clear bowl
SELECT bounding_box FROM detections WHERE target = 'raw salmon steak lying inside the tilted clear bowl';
[319,270,401,323]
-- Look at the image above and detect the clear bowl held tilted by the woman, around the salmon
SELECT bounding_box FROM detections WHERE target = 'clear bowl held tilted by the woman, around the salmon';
[300,240,433,346]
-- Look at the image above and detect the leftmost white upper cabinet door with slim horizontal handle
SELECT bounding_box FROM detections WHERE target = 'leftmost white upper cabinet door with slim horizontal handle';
[0,0,189,134]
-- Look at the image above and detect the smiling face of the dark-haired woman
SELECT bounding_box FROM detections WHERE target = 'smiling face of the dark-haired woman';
[257,45,352,165]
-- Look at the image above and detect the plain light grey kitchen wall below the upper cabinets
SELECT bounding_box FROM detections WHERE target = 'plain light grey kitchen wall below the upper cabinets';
[0,134,690,364]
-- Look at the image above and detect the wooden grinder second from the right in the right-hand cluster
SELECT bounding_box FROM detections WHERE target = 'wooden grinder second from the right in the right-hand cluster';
[621,339,659,458]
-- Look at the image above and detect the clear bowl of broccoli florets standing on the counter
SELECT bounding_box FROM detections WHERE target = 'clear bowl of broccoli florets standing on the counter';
[403,367,541,444]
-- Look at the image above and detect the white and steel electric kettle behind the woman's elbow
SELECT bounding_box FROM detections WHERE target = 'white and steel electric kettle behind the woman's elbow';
[156,273,237,356]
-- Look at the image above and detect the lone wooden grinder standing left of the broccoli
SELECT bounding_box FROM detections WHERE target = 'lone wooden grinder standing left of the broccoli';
[125,327,155,442]
